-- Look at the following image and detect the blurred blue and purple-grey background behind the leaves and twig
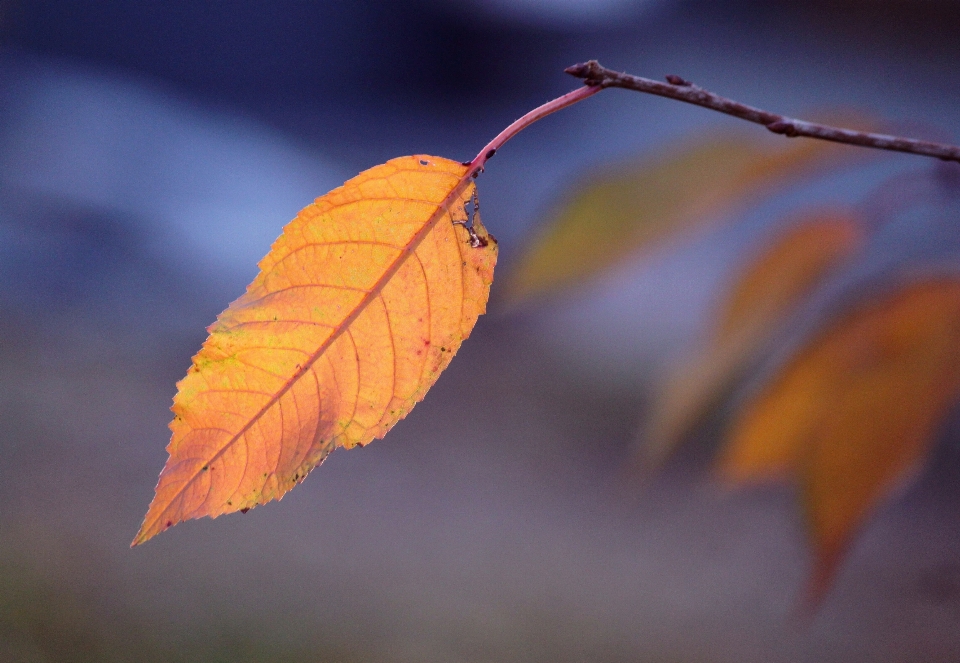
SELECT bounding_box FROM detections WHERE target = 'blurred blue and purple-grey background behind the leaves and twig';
[0,0,960,663]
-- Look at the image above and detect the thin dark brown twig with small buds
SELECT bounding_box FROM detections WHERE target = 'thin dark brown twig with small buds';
[566,60,960,162]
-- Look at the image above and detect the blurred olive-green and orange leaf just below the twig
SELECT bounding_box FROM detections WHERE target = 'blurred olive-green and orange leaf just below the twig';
[506,125,863,303]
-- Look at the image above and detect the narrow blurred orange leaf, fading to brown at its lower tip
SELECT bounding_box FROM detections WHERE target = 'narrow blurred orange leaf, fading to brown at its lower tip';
[638,210,866,470]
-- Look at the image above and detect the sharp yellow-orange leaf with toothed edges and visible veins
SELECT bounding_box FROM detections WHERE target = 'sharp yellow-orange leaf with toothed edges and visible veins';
[133,156,497,545]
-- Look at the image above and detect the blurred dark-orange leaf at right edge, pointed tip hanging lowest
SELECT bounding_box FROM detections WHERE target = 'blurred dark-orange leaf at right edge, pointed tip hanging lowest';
[798,279,960,603]
